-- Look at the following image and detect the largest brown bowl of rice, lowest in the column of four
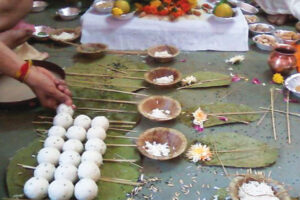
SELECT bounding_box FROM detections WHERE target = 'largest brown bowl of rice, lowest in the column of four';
[136,127,187,160]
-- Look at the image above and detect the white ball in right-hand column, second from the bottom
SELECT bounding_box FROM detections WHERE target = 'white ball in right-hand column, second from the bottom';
[78,162,101,181]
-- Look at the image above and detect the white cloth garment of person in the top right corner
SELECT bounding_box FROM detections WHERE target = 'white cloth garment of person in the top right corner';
[255,0,300,20]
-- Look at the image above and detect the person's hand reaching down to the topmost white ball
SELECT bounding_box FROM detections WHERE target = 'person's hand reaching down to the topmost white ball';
[24,66,74,109]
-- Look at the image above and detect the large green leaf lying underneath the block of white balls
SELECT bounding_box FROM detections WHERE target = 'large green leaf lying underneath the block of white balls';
[6,132,140,200]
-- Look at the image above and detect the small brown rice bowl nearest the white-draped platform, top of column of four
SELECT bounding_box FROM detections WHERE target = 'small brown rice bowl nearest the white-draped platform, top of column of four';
[147,45,180,63]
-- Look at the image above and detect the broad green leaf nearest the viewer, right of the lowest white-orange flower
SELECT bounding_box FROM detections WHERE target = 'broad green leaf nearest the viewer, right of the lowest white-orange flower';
[199,133,278,168]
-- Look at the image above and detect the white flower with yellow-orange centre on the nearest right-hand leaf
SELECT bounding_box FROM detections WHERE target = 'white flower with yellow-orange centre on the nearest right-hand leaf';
[186,143,212,163]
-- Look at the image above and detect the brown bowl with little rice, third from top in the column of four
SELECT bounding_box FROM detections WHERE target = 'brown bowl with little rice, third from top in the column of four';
[138,96,181,122]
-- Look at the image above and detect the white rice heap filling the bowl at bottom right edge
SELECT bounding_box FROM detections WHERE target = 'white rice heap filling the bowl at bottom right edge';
[239,181,279,200]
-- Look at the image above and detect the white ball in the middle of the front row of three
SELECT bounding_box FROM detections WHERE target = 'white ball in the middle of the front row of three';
[48,179,74,200]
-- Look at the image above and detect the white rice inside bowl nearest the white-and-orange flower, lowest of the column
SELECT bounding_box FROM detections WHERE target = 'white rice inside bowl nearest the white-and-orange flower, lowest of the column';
[143,141,170,157]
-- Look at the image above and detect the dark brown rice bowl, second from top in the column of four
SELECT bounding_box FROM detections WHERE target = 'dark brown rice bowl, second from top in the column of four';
[144,67,182,88]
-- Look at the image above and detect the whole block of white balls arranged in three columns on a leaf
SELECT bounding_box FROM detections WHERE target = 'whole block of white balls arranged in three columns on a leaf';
[24,106,109,200]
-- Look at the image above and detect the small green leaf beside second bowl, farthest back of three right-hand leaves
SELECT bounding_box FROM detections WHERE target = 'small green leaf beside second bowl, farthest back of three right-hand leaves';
[180,71,231,88]
